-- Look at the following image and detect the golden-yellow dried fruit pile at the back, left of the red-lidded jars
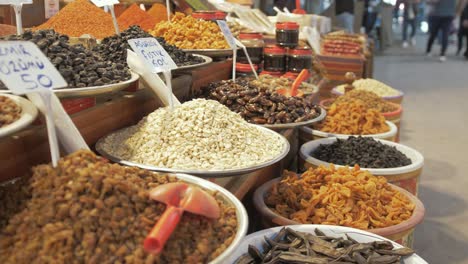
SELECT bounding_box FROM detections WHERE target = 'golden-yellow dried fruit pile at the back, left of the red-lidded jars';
[150,13,229,49]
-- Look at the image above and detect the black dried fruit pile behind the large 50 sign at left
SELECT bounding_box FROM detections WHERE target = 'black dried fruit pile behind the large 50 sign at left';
[2,30,131,88]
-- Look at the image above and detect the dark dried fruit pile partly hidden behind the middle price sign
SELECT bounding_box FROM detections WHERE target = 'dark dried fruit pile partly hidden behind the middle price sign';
[94,26,203,66]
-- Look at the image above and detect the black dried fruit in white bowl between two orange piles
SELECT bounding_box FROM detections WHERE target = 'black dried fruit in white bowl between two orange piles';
[311,137,411,169]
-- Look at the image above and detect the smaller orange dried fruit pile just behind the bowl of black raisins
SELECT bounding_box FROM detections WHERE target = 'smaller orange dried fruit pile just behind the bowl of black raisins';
[317,102,390,135]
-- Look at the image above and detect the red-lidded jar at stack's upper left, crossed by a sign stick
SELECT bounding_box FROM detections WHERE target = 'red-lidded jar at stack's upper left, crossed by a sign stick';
[237,32,265,64]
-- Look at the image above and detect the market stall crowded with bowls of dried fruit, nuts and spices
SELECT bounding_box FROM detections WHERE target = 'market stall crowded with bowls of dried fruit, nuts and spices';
[0,0,425,263]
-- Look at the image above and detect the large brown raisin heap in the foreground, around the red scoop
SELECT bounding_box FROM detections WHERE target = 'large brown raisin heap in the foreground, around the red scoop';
[0,151,237,263]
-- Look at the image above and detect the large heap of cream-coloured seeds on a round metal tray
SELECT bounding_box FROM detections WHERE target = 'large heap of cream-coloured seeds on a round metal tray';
[103,99,284,171]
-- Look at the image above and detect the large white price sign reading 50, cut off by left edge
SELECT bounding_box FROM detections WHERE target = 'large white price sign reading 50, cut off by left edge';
[0,41,67,94]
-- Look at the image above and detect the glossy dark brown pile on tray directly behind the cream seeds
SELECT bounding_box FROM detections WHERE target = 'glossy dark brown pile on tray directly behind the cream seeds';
[202,78,321,124]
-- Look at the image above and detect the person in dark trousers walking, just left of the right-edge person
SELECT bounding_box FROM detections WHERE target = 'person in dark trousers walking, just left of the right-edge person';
[426,0,457,62]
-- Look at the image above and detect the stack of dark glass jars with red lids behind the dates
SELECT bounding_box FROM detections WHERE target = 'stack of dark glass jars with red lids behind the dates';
[236,22,312,79]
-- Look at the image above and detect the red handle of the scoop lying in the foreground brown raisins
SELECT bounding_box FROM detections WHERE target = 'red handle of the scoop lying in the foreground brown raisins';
[143,205,184,254]
